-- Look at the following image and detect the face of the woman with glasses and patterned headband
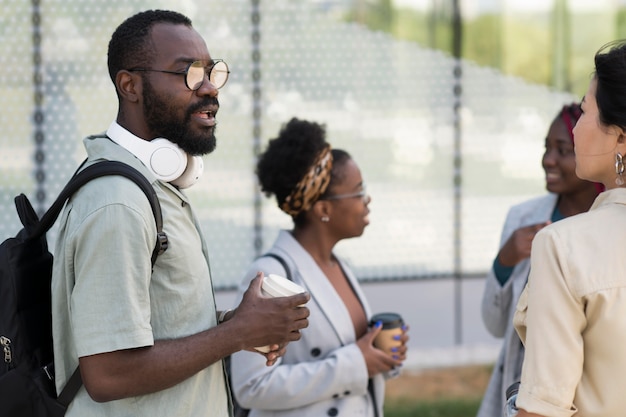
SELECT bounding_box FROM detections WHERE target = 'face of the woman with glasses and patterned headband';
[326,159,372,240]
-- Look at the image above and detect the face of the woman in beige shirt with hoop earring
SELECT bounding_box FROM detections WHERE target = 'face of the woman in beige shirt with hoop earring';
[574,78,626,189]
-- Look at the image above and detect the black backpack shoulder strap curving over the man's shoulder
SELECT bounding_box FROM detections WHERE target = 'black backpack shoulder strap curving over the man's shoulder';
[23,161,168,265]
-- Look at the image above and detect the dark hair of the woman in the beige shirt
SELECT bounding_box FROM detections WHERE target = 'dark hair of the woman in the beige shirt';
[594,40,626,129]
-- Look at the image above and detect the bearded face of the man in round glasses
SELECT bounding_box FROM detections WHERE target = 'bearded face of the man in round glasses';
[142,24,219,155]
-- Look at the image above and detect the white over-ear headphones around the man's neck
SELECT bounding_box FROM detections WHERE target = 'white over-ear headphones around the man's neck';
[107,121,204,188]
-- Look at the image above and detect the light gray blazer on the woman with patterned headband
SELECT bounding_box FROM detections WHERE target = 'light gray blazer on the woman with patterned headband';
[231,230,385,417]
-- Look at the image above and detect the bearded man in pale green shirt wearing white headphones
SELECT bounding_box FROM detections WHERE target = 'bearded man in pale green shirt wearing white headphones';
[52,10,309,417]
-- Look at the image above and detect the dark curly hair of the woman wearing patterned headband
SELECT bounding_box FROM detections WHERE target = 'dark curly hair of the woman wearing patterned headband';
[256,117,350,223]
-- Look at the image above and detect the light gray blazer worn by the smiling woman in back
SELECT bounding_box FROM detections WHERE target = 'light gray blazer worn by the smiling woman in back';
[477,193,558,417]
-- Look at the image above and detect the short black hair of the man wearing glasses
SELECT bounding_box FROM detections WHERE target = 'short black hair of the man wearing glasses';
[107,10,191,84]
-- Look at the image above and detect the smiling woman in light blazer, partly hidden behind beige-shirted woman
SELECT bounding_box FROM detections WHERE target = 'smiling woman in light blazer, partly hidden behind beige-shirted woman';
[478,103,601,417]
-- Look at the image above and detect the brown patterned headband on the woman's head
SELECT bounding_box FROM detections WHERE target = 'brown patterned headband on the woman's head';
[280,145,333,217]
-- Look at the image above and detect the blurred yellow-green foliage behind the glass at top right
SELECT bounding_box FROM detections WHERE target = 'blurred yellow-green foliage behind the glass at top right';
[346,0,626,95]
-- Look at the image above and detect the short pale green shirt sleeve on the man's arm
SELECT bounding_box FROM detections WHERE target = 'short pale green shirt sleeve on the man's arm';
[65,204,156,356]
